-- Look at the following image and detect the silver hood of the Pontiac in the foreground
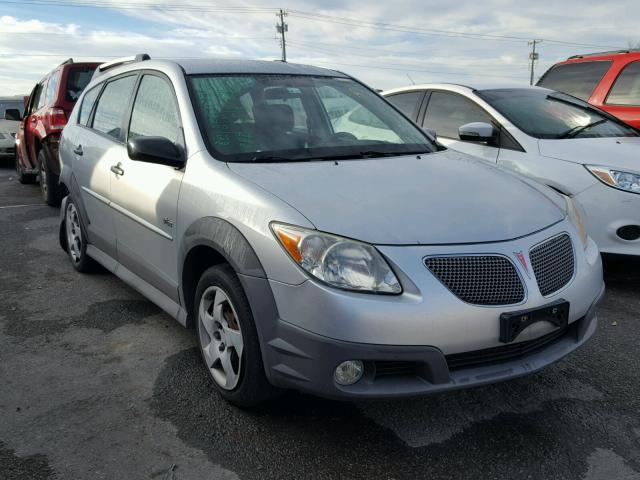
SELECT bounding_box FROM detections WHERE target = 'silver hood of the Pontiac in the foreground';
[229,150,564,245]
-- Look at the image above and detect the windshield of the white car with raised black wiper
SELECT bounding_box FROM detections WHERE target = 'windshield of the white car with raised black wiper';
[477,88,640,139]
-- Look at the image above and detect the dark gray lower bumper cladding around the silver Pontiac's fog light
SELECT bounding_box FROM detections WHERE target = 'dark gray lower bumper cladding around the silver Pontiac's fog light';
[241,270,604,400]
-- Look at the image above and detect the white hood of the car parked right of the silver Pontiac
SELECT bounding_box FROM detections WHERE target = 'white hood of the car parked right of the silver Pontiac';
[538,137,640,172]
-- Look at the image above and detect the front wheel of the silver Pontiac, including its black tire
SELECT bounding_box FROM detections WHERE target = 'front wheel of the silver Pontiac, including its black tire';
[194,264,281,408]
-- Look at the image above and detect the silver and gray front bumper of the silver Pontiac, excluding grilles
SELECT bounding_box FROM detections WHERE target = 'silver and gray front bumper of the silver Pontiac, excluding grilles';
[248,221,604,398]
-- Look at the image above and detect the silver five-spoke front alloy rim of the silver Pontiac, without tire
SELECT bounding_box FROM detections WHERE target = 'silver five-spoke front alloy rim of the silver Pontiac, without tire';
[198,287,244,390]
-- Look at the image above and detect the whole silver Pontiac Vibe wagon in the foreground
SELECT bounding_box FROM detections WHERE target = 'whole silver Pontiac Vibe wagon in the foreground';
[60,54,604,406]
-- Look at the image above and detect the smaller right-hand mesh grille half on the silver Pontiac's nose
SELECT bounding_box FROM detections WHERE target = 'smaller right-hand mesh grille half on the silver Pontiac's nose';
[529,233,575,296]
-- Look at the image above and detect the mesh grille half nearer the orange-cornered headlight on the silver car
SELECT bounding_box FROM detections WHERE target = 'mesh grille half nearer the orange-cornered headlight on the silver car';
[424,255,524,305]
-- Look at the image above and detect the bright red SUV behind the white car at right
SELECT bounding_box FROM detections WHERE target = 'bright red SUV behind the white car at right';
[538,50,640,128]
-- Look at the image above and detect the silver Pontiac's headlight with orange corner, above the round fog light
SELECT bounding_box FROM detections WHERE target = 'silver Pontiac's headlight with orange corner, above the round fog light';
[271,223,402,294]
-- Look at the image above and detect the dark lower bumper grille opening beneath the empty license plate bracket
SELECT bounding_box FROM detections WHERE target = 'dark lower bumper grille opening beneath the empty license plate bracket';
[445,326,572,370]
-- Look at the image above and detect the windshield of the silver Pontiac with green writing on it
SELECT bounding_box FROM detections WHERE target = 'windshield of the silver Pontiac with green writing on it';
[190,75,436,162]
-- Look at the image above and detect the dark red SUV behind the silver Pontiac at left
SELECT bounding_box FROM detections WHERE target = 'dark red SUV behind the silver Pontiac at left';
[16,59,99,206]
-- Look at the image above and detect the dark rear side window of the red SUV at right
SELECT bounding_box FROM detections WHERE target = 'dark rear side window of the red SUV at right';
[538,61,611,101]
